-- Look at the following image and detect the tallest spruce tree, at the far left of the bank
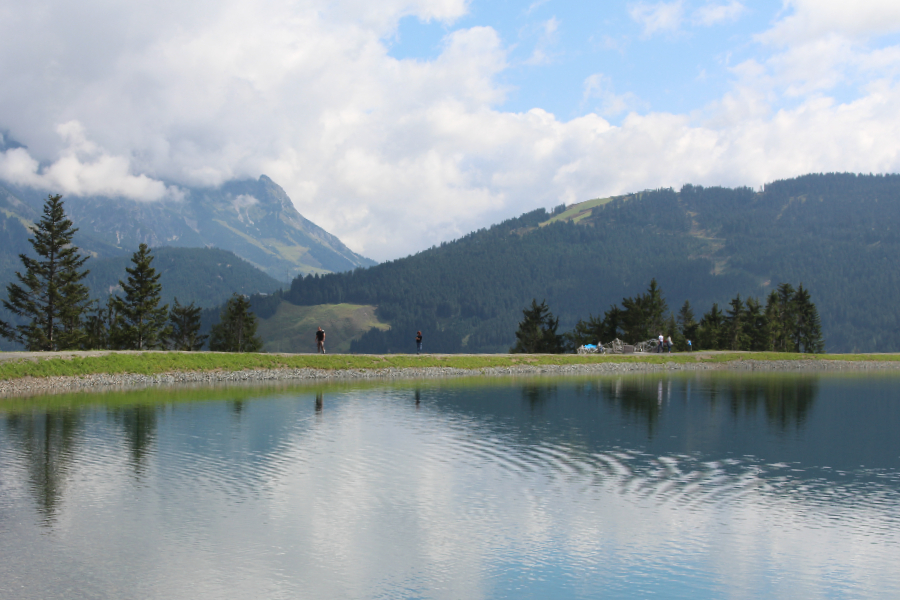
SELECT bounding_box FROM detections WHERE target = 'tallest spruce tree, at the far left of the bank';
[0,194,89,351]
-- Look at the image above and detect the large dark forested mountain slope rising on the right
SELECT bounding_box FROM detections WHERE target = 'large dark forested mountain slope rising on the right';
[266,174,900,352]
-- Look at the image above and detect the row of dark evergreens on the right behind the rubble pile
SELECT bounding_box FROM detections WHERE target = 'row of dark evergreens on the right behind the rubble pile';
[510,279,825,354]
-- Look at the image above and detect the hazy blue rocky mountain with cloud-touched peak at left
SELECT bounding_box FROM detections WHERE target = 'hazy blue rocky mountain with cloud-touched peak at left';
[0,175,375,281]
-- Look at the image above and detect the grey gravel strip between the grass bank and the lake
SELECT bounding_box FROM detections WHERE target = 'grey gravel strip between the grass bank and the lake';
[0,360,900,397]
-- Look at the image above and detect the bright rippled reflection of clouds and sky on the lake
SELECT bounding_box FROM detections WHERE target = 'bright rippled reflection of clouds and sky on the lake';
[0,380,900,598]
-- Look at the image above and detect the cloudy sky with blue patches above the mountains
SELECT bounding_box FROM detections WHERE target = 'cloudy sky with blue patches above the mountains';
[0,0,900,261]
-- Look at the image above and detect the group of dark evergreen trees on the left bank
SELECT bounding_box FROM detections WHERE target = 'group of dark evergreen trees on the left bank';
[0,195,262,352]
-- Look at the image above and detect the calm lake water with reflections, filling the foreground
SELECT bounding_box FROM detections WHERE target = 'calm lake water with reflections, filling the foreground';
[0,374,900,600]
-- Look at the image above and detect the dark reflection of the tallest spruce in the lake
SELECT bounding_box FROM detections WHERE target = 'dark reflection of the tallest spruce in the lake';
[6,409,82,524]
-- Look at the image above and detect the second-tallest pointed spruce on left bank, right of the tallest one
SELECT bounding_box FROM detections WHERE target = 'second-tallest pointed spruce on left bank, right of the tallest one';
[112,244,169,350]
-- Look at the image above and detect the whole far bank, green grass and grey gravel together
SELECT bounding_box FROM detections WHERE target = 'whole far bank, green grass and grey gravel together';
[0,351,900,395]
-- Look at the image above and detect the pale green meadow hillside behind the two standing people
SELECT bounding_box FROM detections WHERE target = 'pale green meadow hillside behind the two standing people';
[257,302,390,353]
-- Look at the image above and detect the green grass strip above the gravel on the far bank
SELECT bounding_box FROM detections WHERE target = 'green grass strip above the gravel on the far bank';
[0,352,900,380]
